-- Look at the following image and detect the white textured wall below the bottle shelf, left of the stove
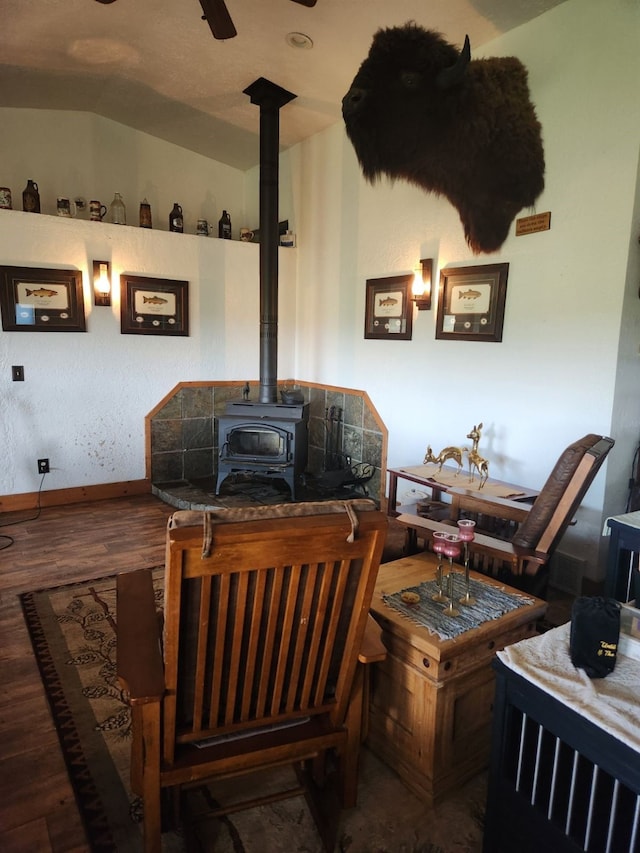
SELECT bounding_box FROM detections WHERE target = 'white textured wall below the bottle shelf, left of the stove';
[0,211,295,495]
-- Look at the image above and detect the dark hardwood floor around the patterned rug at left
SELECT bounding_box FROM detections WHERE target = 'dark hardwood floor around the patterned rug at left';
[0,495,173,853]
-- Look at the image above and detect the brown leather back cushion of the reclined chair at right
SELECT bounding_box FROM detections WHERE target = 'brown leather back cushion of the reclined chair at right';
[511,433,602,550]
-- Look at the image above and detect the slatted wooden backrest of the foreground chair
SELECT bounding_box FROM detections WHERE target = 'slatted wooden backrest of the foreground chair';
[163,501,387,762]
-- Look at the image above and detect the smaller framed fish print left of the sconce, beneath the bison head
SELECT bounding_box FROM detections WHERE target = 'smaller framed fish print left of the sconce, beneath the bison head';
[364,273,413,341]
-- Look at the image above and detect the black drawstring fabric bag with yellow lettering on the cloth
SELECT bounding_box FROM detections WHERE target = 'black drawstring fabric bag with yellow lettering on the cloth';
[569,596,620,678]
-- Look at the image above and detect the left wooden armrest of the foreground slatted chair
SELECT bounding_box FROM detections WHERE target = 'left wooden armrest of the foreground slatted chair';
[116,569,164,705]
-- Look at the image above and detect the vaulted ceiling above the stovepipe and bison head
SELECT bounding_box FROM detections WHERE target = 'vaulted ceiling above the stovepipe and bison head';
[0,0,565,170]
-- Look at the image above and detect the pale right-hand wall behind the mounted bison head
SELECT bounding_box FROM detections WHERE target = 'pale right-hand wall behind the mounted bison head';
[289,0,640,571]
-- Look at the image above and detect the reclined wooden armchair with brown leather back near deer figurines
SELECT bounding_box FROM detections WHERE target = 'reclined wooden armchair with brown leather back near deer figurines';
[397,434,614,597]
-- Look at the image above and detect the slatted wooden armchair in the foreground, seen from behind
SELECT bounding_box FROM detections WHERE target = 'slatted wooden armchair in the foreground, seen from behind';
[117,500,387,853]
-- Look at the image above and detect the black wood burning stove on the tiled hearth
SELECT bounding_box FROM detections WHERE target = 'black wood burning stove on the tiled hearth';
[216,400,309,501]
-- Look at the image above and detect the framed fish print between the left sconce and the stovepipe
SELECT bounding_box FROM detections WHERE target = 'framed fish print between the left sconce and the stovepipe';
[120,274,189,337]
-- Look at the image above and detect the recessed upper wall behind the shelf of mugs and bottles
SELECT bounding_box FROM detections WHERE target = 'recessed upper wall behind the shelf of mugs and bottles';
[0,108,257,238]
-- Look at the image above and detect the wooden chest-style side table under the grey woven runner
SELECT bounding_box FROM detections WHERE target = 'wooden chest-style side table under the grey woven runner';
[368,553,547,806]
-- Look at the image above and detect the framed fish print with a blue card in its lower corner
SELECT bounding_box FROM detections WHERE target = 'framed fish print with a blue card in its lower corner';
[0,267,87,332]
